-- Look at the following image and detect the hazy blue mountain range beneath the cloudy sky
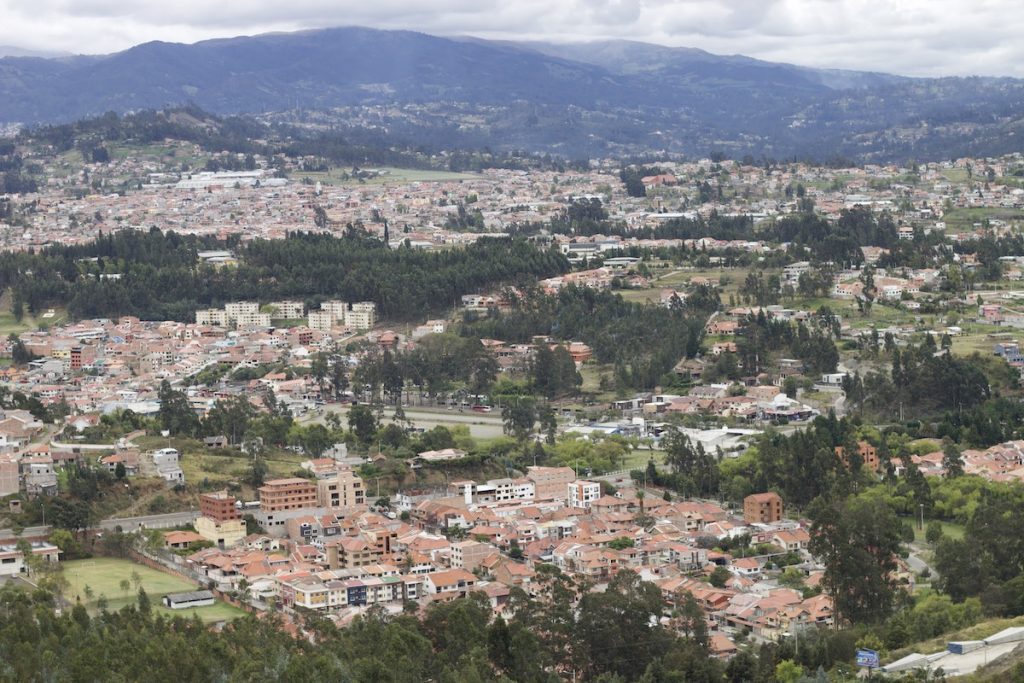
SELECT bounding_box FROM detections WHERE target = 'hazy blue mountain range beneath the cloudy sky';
[0,28,1024,160]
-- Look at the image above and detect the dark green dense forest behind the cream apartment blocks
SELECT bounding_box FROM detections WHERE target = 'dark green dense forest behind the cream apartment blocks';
[0,229,568,321]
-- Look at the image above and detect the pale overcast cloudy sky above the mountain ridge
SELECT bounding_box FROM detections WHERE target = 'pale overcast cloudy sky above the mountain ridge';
[0,0,1024,77]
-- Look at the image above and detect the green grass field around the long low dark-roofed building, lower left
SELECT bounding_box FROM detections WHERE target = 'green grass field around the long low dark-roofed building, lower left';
[63,558,245,622]
